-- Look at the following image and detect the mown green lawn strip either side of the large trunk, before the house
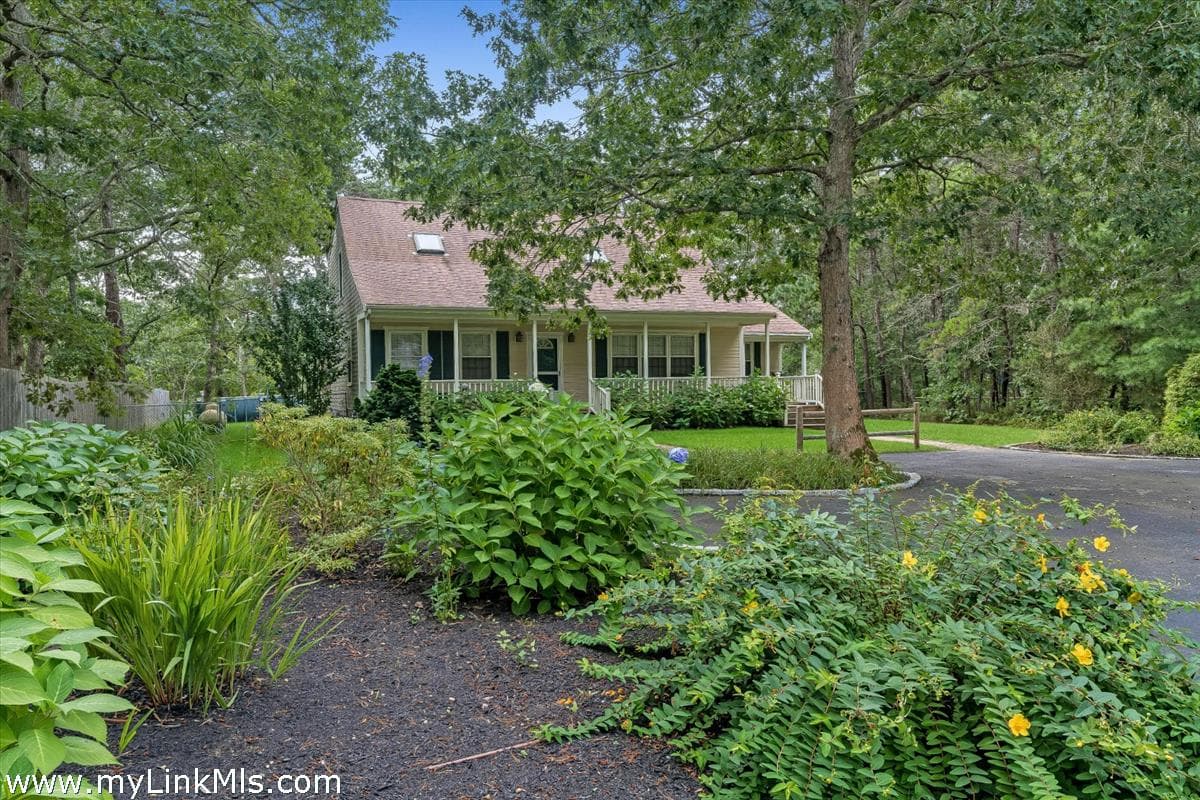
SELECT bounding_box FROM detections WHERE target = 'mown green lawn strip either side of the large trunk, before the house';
[654,419,1042,452]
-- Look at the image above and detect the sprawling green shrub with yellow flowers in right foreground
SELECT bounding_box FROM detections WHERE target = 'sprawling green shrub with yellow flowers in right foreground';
[540,493,1200,800]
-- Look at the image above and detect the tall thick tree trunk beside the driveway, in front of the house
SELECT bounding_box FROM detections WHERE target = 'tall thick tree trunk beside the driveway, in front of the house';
[817,12,875,461]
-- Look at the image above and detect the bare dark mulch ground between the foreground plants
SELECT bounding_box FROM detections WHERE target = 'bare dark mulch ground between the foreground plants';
[104,575,698,800]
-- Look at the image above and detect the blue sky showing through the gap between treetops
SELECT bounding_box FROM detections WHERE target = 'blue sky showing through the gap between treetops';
[374,0,575,120]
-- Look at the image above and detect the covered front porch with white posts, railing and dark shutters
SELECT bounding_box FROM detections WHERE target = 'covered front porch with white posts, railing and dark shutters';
[352,308,822,411]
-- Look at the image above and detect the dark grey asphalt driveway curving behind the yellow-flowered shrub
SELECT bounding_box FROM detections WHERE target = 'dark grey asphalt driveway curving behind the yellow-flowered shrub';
[692,447,1200,640]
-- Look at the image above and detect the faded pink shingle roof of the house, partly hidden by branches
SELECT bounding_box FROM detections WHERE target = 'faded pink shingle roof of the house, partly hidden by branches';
[337,196,809,336]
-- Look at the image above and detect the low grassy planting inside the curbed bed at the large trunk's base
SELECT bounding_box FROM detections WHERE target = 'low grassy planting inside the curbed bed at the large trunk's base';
[683,447,901,489]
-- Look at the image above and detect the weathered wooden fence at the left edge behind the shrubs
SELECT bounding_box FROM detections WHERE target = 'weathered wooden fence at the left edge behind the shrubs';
[0,369,175,431]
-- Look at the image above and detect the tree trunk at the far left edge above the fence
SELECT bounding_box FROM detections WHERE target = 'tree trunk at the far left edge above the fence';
[0,2,29,367]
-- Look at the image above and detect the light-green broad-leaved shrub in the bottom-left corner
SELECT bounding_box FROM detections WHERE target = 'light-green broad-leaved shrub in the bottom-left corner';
[0,499,133,796]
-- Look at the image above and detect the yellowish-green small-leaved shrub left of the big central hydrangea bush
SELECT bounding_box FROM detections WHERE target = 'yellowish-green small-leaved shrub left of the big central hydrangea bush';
[254,403,414,546]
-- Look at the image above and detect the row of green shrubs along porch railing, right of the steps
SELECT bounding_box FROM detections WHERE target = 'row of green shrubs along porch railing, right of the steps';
[600,374,787,428]
